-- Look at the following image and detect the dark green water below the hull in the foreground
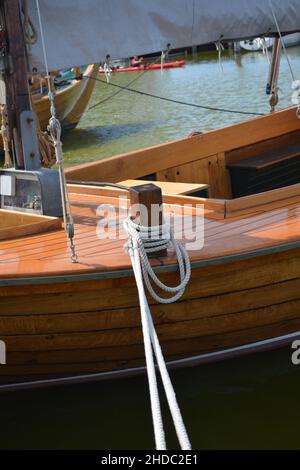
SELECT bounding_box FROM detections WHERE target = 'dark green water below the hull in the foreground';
[0,348,300,449]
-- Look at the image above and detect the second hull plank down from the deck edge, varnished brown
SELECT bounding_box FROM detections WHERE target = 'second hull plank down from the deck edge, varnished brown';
[0,278,300,337]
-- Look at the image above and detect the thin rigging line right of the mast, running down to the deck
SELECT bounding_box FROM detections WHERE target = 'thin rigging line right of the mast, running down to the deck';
[35,0,77,263]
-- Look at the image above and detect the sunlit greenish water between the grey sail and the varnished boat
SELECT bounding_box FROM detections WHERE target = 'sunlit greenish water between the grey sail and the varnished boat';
[64,48,300,165]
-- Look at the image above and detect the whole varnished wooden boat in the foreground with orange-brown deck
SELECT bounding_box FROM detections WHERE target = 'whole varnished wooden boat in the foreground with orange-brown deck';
[0,0,300,390]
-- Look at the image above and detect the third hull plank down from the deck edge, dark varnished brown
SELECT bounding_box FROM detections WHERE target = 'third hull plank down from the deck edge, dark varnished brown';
[2,299,300,351]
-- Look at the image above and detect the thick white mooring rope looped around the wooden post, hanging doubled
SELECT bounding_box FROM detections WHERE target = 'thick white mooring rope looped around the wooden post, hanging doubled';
[124,218,191,450]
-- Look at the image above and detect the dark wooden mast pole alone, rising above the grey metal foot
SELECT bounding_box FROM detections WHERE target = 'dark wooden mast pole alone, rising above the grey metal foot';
[2,0,31,169]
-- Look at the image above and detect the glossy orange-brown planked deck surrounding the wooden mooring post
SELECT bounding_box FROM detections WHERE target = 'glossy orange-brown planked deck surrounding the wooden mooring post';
[0,185,300,278]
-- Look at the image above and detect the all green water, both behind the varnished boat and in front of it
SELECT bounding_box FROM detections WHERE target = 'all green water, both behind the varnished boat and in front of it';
[0,48,300,449]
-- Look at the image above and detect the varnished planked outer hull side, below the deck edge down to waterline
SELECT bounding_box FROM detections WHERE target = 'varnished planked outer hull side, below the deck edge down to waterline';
[0,244,300,384]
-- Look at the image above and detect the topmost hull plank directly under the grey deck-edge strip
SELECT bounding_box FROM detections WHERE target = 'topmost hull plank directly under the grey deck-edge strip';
[0,246,300,315]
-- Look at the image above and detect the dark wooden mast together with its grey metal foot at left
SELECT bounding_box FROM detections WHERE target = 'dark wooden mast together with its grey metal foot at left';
[0,0,62,217]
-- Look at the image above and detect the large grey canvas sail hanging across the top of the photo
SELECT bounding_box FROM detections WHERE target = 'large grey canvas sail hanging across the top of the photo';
[29,0,300,70]
